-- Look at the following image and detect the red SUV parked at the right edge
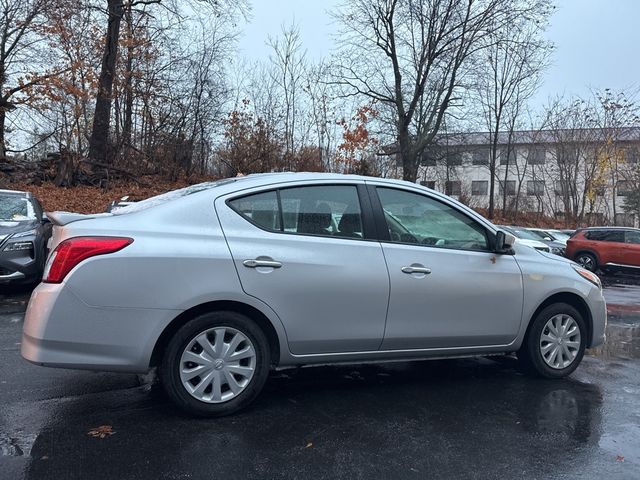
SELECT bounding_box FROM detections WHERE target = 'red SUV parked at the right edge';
[566,227,640,272]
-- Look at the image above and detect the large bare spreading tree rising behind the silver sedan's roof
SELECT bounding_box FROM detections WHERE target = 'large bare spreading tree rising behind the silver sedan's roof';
[335,0,544,181]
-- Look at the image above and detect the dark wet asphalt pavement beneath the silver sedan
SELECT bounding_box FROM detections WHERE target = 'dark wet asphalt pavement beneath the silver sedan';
[0,277,640,480]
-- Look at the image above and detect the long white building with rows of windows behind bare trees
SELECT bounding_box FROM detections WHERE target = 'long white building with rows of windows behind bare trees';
[418,128,640,226]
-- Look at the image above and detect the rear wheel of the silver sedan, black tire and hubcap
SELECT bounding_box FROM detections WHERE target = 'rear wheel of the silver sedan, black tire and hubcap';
[160,312,270,417]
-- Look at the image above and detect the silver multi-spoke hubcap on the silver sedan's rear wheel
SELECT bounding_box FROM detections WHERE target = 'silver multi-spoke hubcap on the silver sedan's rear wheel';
[179,327,256,403]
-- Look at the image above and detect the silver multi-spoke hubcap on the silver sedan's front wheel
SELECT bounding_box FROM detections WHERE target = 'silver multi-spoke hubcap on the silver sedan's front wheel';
[540,314,580,370]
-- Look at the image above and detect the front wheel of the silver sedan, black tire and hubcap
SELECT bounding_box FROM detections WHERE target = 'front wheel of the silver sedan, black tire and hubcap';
[517,303,587,378]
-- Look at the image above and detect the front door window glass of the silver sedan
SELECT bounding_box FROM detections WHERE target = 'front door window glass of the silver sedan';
[377,187,489,251]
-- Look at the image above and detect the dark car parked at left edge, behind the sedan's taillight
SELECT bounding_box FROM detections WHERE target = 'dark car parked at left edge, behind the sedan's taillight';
[0,190,51,285]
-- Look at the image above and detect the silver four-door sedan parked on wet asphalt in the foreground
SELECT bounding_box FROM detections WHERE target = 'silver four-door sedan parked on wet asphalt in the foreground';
[22,173,606,416]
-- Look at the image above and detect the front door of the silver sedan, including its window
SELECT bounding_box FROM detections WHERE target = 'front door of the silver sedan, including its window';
[372,185,523,350]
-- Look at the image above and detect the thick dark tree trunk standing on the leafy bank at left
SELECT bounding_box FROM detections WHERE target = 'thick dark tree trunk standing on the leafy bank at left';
[89,0,123,164]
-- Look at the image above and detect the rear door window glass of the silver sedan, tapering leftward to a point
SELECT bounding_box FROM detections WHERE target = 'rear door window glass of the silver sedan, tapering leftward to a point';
[229,185,364,239]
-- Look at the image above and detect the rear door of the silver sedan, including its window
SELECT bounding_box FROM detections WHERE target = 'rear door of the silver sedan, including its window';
[216,184,389,354]
